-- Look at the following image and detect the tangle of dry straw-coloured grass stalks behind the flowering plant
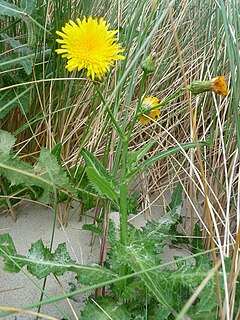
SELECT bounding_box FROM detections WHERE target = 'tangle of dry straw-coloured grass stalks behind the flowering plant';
[1,0,240,319]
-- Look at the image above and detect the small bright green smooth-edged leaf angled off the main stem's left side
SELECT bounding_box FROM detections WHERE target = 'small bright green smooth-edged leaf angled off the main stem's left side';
[86,167,119,203]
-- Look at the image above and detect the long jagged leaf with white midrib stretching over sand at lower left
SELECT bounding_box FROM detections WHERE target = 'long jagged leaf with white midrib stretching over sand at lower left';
[0,234,116,285]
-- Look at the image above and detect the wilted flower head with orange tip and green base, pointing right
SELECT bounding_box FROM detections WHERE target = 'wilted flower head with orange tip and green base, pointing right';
[189,76,228,96]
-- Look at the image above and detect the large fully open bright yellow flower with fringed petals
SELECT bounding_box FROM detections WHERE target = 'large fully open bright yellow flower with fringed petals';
[56,17,125,80]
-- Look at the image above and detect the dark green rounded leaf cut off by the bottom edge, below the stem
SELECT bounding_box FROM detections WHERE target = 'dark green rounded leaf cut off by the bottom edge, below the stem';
[81,298,132,320]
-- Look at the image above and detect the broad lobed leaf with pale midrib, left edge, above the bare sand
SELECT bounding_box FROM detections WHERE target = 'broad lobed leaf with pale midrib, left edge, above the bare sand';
[0,130,76,203]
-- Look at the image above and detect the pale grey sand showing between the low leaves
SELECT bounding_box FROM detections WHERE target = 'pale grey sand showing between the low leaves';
[0,196,201,320]
